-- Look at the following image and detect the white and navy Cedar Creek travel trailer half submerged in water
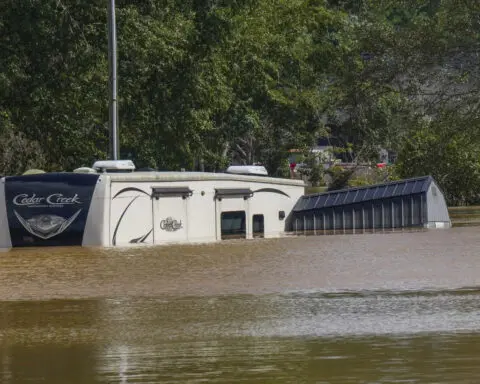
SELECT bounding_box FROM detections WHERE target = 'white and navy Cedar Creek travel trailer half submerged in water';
[0,161,304,248]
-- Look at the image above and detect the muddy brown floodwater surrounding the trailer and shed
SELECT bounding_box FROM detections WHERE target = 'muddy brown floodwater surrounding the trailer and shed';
[0,227,480,384]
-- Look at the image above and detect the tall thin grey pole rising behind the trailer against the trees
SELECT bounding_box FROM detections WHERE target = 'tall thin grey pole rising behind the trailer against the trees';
[108,0,120,160]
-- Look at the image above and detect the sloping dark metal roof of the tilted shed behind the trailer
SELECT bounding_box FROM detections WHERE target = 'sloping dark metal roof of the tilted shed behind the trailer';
[293,176,433,212]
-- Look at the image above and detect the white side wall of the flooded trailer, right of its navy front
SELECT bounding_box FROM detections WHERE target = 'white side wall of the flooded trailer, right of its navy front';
[110,180,303,246]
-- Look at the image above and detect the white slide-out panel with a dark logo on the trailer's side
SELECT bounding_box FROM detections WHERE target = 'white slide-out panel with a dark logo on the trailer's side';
[152,187,192,244]
